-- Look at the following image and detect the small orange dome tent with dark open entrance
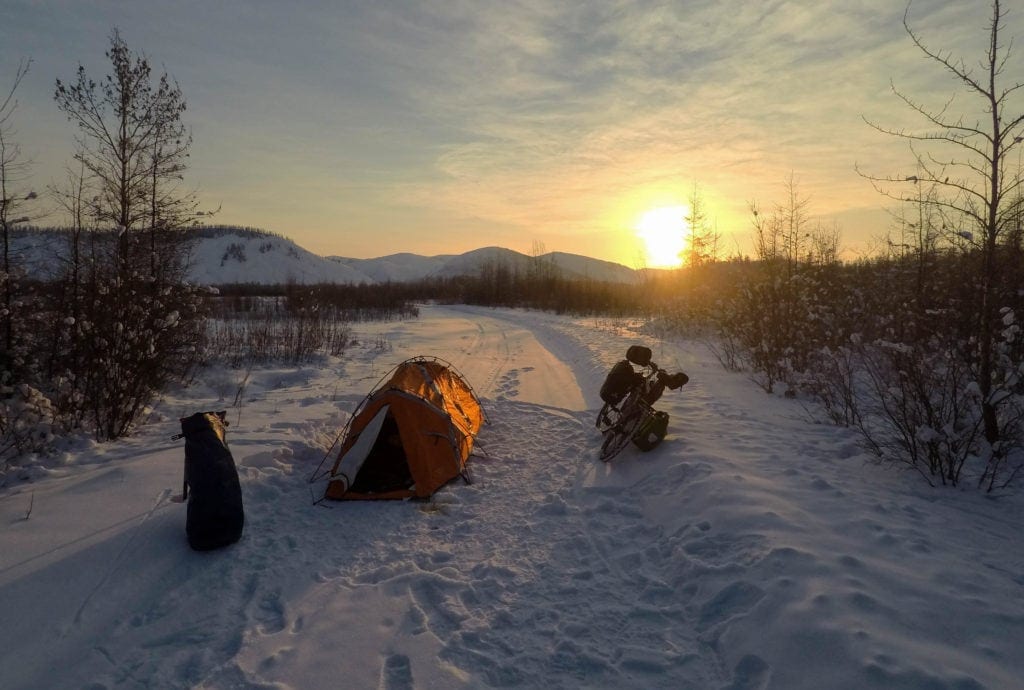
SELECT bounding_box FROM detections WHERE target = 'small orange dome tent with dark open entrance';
[325,357,484,500]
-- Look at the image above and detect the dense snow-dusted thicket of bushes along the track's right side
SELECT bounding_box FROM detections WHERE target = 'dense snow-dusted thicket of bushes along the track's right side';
[664,222,1024,490]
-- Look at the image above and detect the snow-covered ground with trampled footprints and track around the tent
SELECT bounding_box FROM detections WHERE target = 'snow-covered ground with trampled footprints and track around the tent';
[0,306,1024,690]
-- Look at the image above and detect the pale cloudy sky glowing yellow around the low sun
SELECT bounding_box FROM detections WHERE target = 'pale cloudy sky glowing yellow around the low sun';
[0,0,1024,267]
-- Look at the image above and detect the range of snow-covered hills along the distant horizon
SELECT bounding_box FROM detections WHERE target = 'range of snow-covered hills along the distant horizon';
[13,226,641,285]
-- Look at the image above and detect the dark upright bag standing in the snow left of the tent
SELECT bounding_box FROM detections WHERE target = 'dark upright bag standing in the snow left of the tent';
[181,412,245,551]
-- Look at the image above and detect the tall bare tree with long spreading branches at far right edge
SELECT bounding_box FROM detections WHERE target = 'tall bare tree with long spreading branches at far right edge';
[862,0,1024,483]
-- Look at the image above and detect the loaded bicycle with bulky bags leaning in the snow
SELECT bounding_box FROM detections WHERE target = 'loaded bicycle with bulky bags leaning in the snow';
[596,345,689,462]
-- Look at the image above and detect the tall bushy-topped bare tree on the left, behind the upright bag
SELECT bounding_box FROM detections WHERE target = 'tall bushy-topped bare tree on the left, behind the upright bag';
[54,30,203,440]
